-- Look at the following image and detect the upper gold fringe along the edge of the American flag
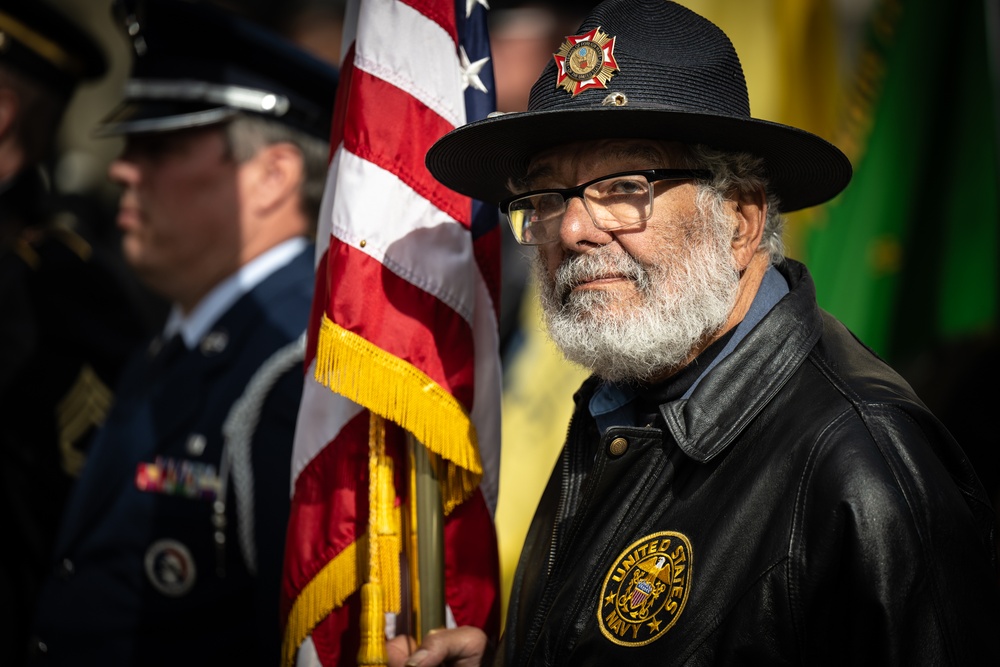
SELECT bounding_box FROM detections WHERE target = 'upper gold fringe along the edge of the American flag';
[315,314,483,515]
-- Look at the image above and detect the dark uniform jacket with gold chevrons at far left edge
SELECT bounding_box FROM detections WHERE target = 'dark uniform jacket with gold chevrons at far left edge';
[0,169,145,664]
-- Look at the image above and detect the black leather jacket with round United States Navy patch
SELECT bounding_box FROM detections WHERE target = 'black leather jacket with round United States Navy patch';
[498,261,1000,667]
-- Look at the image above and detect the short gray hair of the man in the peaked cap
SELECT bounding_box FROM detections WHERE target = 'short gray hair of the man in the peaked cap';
[225,113,330,234]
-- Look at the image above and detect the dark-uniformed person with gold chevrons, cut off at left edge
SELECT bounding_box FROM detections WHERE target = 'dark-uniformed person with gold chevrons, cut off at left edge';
[0,0,145,665]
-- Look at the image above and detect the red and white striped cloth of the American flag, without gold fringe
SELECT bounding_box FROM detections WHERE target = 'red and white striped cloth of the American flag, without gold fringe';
[283,0,501,667]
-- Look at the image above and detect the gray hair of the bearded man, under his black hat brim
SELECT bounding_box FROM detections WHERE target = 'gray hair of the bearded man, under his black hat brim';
[678,144,785,264]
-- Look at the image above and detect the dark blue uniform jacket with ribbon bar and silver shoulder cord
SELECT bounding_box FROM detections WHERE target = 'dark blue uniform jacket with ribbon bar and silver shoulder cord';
[35,245,314,665]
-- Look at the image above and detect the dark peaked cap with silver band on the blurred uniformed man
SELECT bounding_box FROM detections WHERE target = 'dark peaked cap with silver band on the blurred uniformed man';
[94,0,338,141]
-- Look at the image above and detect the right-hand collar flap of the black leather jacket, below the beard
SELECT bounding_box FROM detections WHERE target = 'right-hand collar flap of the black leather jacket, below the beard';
[660,260,823,463]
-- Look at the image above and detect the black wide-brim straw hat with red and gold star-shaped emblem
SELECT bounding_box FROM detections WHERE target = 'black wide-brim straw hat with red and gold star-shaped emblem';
[426,0,852,212]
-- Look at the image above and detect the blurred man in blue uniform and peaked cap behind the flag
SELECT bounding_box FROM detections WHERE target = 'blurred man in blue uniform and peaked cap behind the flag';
[34,0,337,666]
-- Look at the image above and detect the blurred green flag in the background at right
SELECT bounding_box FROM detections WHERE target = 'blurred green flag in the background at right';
[804,0,1000,363]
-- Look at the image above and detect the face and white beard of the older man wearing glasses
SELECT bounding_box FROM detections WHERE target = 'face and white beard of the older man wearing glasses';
[532,140,756,383]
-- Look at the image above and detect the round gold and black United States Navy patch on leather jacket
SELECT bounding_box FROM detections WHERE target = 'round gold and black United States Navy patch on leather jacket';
[597,531,694,646]
